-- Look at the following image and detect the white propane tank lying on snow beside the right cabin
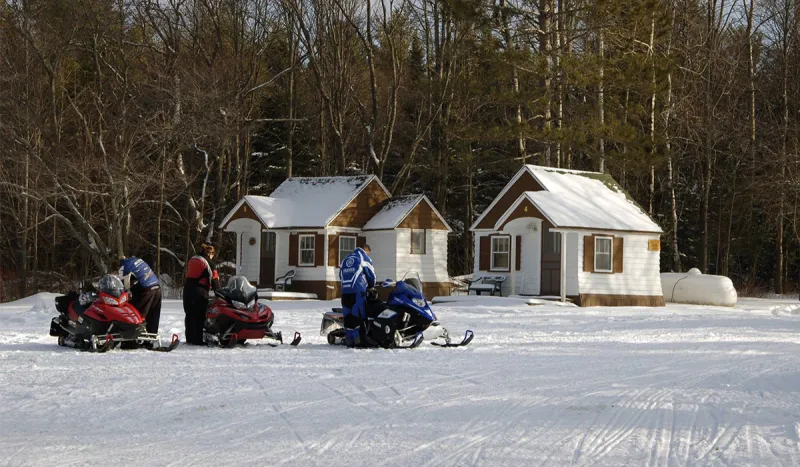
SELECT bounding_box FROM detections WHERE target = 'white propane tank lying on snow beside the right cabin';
[661,268,737,306]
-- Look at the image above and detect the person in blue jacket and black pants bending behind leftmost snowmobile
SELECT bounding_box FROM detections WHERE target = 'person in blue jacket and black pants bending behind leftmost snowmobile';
[119,256,161,334]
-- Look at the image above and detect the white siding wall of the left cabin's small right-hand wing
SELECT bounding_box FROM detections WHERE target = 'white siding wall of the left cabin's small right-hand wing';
[395,229,450,282]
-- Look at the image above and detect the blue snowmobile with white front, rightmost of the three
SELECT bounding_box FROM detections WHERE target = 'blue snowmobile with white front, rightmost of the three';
[320,274,474,349]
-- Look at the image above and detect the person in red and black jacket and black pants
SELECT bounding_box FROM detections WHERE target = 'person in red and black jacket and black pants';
[183,241,219,345]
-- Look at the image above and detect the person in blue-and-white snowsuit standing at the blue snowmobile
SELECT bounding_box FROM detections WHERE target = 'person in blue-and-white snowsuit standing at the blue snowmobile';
[339,245,375,347]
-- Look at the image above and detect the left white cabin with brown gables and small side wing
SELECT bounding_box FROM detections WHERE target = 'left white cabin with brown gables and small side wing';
[222,175,450,299]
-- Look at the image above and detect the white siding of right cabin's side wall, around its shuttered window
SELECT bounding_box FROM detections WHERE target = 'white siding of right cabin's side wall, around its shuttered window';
[574,232,662,296]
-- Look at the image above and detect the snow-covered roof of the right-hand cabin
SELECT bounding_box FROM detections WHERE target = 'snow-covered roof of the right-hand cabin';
[482,165,663,233]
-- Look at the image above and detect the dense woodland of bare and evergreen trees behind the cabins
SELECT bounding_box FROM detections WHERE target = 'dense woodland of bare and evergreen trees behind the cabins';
[0,0,800,300]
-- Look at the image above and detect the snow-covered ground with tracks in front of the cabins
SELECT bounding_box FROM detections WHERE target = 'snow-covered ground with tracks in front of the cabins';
[0,295,800,466]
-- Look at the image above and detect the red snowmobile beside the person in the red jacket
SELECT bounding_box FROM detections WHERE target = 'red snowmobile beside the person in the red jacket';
[204,276,301,347]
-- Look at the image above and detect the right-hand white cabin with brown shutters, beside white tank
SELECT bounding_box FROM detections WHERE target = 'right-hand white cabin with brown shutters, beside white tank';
[471,165,664,306]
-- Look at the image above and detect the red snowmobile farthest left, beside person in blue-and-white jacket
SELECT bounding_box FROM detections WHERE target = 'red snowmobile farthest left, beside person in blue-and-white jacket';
[50,275,180,353]
